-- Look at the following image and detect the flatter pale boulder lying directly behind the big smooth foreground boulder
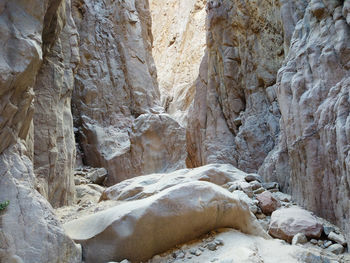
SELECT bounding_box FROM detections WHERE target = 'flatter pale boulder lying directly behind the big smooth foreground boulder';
[100,164,246,201]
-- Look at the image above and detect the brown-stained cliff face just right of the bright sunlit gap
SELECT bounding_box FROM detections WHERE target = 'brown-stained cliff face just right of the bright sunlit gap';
[187,1,284,172]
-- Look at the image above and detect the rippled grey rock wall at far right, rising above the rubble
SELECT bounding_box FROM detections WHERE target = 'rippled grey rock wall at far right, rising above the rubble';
[260,1,350,243]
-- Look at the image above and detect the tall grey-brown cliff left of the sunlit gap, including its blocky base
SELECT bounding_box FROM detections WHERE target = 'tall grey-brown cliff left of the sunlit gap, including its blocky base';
[73,0,186,184]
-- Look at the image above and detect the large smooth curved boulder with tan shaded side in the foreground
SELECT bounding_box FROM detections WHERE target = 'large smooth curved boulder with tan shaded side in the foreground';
[64,182,268,263]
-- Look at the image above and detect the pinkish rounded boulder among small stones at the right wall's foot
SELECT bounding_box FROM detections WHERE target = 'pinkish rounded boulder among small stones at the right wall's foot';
[269,207,323,243]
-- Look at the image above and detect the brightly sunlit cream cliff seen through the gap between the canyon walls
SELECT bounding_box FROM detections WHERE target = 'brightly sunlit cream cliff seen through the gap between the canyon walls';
[150,0,206,126]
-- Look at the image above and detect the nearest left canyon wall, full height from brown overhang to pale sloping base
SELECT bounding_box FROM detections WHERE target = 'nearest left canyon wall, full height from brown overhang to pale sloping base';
[0,0,81,263]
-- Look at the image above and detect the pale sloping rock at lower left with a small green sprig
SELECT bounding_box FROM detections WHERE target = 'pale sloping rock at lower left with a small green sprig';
[0,144,81,263]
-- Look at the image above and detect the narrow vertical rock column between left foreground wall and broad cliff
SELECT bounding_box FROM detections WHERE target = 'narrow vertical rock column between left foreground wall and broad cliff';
[34,1,79,207]
